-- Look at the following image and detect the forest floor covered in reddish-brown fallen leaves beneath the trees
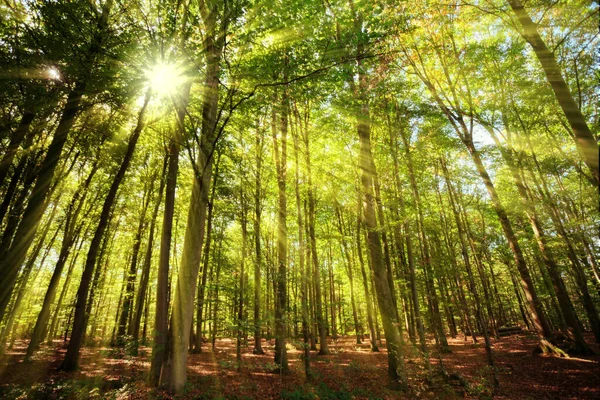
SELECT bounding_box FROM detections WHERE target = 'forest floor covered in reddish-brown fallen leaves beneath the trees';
[0,334,600,399]
